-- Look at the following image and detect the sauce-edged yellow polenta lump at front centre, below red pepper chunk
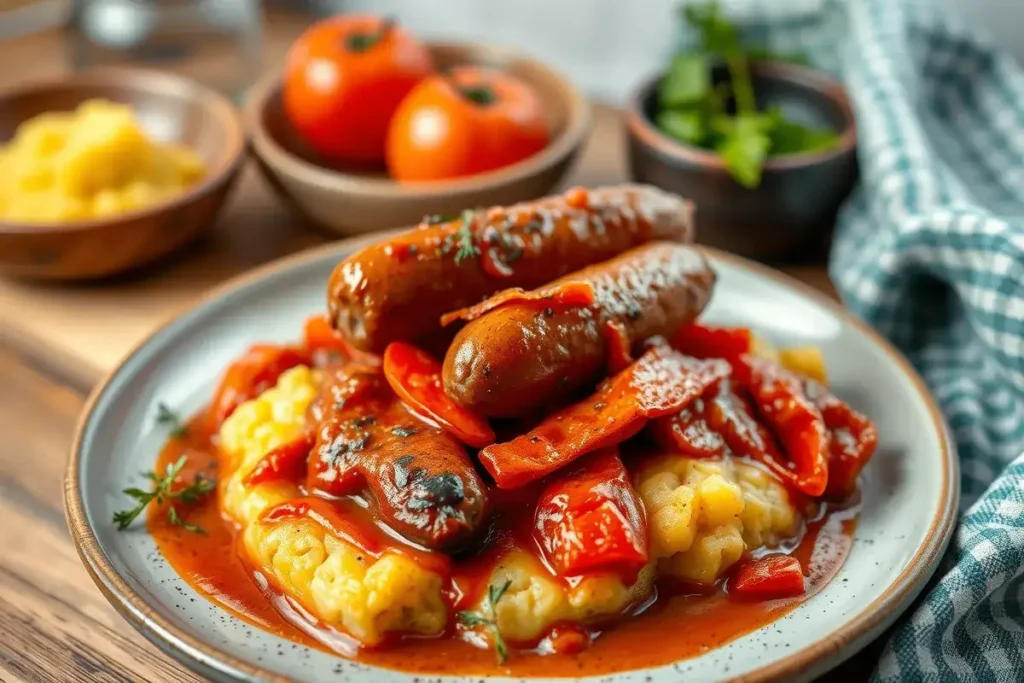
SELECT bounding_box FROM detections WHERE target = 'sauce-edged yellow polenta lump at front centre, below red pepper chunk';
[477,551,654,641]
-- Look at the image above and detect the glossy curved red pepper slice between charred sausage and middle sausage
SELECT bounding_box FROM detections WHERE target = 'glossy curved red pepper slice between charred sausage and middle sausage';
[384,342,495,449]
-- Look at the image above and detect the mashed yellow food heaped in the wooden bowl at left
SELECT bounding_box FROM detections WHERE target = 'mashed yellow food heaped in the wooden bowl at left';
[0,99,206,223]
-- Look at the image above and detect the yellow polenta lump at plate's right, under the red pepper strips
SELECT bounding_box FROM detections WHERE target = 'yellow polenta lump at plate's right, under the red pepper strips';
[636,454,800,584]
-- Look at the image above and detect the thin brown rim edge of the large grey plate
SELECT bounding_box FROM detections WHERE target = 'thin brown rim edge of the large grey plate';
[63,237,961,683]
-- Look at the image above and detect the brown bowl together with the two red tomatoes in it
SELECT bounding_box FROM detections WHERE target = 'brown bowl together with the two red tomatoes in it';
[244,15,591,234]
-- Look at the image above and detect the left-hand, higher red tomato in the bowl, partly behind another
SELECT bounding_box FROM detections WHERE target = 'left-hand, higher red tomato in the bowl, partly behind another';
[282,15,433,165]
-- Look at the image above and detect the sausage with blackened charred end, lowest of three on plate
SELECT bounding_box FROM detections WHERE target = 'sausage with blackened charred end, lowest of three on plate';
[309,365,489,551]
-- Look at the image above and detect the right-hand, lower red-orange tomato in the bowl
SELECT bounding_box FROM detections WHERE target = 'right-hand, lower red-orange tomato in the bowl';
[387,67,549,180]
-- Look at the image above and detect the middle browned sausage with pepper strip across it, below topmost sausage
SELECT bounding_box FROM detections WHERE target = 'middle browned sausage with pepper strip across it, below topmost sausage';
[443,242,715,417]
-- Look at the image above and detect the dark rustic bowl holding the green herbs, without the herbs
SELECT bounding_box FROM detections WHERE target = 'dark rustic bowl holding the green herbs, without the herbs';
[626,61,857,260]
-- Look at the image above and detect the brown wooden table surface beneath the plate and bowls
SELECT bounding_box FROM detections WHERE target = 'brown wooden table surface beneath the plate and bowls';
[0,6,870,683]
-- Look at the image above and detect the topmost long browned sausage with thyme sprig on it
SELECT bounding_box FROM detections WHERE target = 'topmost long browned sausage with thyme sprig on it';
[328,185,693,352]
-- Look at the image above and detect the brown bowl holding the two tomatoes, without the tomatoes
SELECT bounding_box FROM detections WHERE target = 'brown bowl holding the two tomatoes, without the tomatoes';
[243,44,591,234]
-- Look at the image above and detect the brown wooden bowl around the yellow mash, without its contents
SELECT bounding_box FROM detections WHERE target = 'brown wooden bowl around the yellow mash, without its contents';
[0,69,245,280]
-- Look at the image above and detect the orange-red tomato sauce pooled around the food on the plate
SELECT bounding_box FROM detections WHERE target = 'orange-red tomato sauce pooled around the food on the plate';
[148,416,856,677]
